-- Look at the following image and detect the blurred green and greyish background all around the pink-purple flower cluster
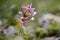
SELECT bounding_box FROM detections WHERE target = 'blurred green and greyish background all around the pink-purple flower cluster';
[0,0,60,40]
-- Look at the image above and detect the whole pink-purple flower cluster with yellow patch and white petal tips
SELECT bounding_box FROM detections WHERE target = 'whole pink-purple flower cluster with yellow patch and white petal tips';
[18,3,36,25]
